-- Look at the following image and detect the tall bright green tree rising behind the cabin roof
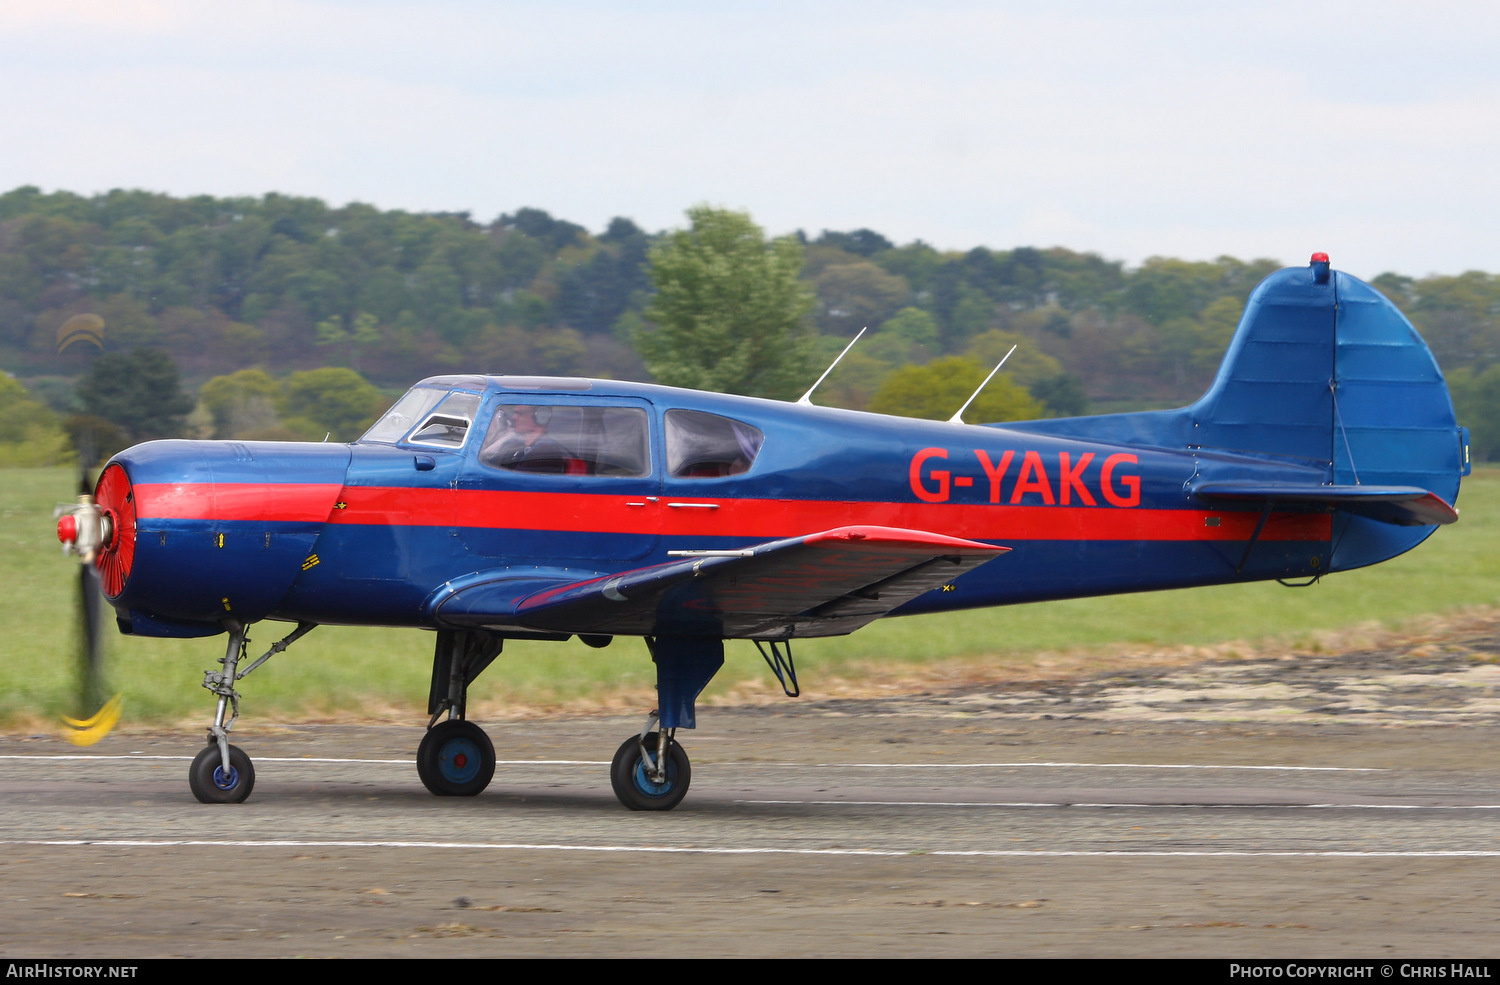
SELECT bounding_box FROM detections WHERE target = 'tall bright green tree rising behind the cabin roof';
[633,205,816,399]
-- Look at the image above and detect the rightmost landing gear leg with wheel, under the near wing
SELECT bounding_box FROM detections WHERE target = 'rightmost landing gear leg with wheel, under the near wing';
[609,636,725,811]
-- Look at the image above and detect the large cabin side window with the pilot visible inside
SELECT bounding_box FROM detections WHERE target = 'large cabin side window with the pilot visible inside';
[479,403,651,477]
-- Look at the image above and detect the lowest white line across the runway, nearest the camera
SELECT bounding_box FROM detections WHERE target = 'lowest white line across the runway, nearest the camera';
[0,838,1500,859]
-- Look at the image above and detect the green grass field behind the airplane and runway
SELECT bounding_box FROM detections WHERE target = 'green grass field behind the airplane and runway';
[0,469,1500,727]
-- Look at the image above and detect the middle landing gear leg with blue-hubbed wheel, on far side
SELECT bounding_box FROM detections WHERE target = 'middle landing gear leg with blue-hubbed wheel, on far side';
[417,630,506,798]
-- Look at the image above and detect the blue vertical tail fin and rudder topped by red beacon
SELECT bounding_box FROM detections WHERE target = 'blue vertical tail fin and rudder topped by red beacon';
[1005,253,1469,570]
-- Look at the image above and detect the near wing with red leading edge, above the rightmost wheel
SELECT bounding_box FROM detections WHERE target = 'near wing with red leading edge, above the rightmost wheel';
[435,526,1010,639]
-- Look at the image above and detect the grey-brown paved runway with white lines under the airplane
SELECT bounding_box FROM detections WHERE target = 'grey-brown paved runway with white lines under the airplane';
[0,697,1500,958]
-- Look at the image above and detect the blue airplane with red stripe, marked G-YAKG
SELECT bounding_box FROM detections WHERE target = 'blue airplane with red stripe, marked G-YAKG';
[59,253,1469,810]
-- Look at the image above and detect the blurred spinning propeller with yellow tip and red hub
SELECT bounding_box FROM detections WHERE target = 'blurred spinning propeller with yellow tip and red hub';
[53,441,123,745]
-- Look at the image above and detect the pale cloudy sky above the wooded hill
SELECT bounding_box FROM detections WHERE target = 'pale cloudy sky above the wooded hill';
[0,0,1500,277]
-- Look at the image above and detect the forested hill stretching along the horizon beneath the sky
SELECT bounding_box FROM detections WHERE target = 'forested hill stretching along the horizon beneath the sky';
[0,187,1500,457]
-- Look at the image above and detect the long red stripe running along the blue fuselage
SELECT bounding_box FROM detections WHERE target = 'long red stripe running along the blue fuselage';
[135,483,1332,541]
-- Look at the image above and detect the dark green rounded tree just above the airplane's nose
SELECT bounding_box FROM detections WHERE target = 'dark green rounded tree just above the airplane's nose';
[78,349,194,441]
